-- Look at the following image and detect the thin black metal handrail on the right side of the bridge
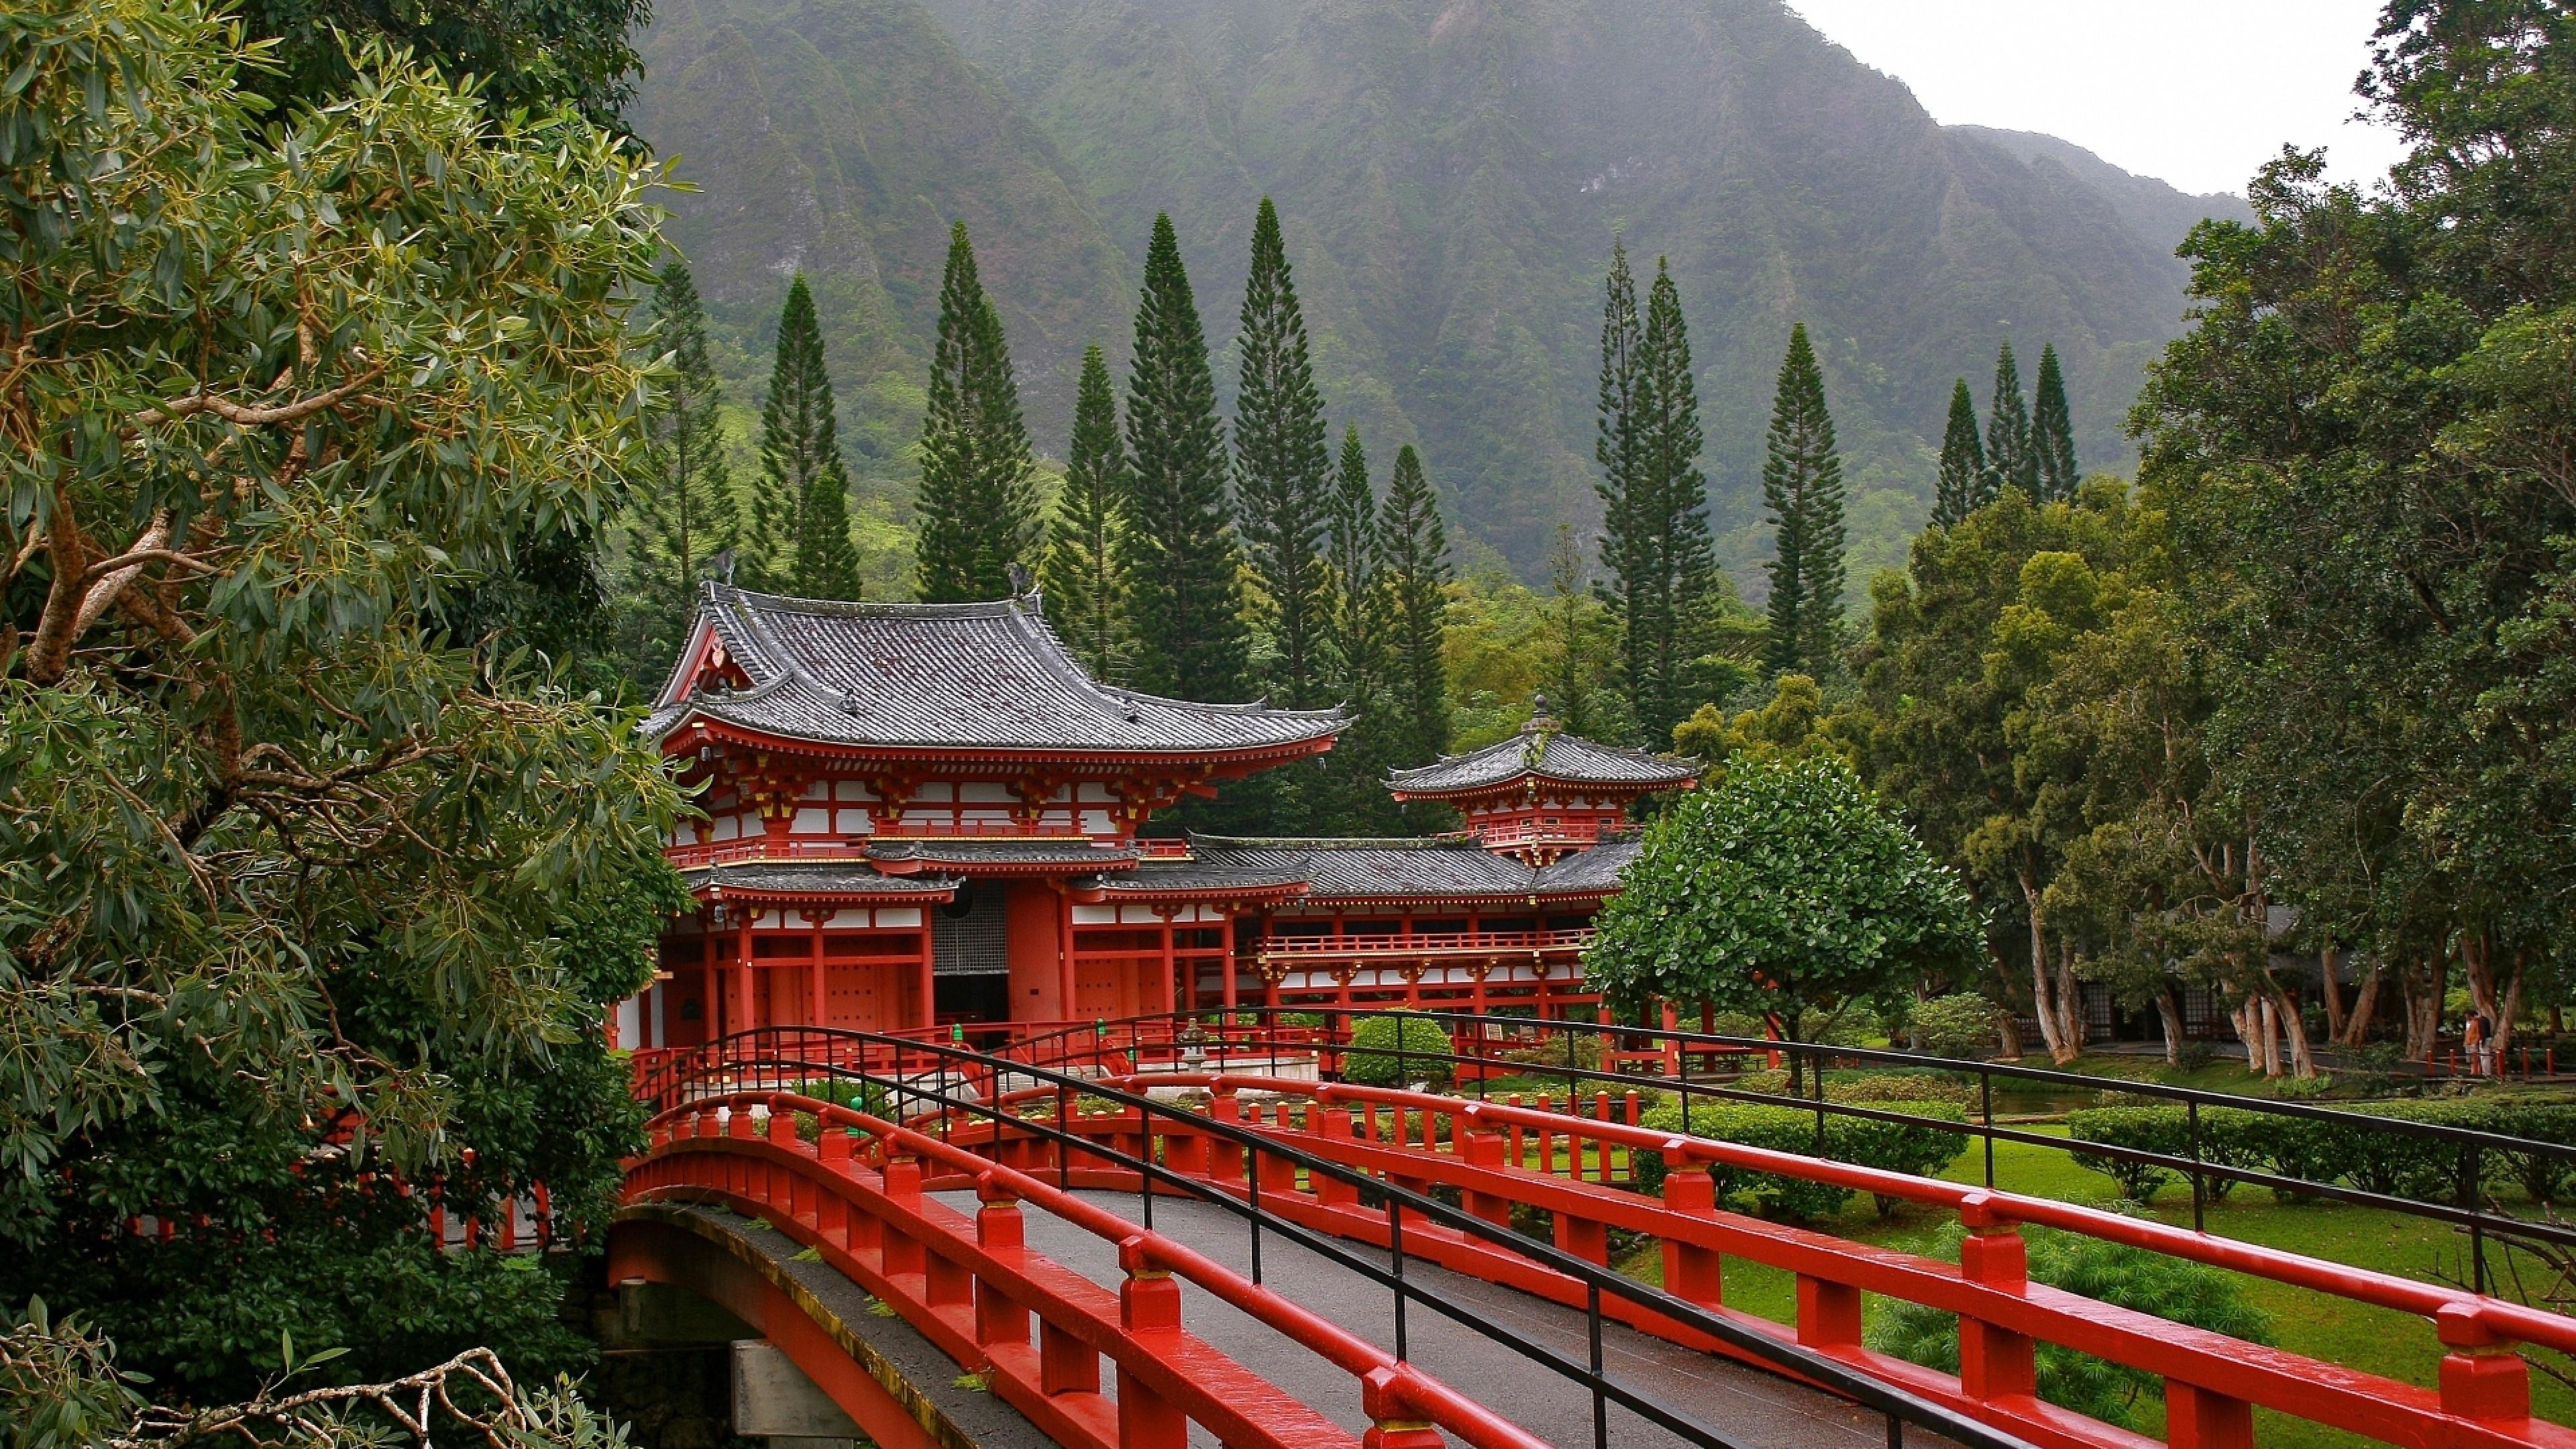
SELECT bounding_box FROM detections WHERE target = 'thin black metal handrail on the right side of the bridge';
[968,1006,2576,1273]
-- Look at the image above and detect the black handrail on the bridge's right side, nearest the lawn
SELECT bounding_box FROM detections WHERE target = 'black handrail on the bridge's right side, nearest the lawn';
[1012,1006,2576,1263]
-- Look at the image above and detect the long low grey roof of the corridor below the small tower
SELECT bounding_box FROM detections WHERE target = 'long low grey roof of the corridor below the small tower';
[1190,835,1633,902]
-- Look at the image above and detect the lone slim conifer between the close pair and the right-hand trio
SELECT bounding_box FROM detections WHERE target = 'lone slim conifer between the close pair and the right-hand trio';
[1762,322,1844,676]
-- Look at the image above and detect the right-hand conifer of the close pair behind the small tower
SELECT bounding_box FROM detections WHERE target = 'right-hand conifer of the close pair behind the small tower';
[1628,258,1721,740]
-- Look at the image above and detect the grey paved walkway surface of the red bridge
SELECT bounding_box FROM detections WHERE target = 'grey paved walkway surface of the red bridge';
[945,1194,1945,1449]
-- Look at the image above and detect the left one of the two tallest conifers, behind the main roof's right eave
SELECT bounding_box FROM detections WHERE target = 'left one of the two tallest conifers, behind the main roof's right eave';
[1126,217,1252,701]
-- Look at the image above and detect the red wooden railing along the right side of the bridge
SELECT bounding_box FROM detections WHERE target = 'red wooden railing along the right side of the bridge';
[1077,1075,2576,1446]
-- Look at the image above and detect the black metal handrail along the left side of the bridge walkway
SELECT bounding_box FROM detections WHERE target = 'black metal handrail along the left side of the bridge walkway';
[649,1026,2035,1449]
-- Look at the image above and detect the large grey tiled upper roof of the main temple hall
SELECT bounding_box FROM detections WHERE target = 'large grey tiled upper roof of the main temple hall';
[644,583,1347,758]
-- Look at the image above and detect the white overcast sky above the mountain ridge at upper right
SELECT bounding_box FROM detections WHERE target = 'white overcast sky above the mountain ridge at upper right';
[1788,0,2398,193]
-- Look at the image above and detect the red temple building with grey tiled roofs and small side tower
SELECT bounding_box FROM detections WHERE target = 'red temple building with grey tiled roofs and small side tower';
[616,583,1693,1046]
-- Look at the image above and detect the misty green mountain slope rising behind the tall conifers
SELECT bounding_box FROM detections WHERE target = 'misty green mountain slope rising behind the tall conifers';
[639,0,2229,583]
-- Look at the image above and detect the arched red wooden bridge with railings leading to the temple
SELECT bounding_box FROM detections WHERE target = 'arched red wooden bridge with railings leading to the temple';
[610,1029,2576,1449]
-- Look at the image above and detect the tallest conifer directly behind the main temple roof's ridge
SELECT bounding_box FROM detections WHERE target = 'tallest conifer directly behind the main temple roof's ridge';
[914,222,1040,603]
